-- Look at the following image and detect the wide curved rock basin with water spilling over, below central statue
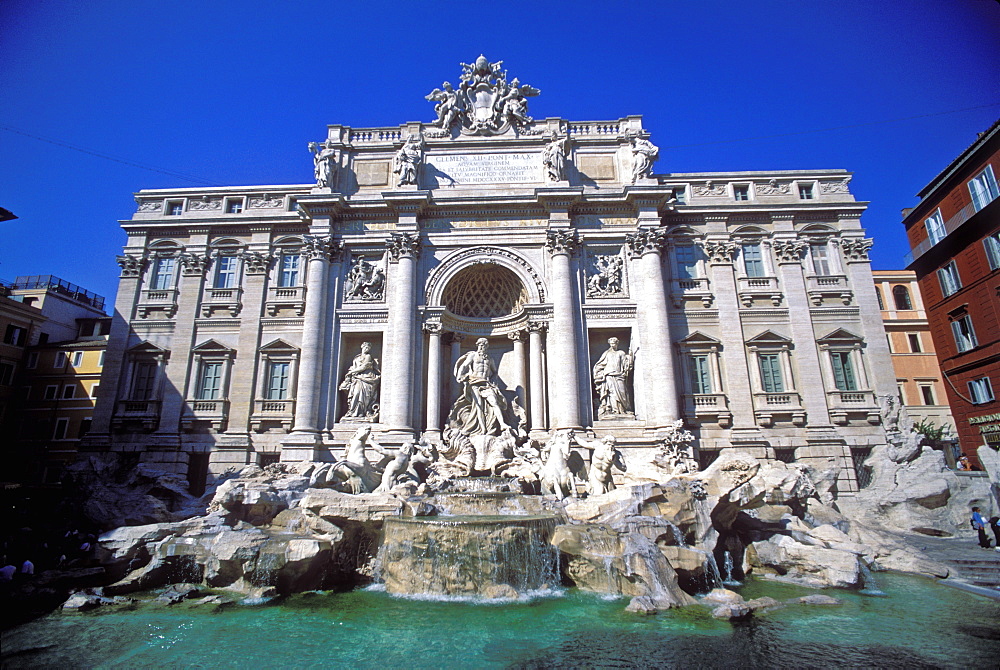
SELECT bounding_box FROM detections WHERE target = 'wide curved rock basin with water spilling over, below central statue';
[378,514,559,599]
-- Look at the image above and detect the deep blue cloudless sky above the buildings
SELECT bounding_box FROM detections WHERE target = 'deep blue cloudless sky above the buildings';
[0,0,1000,308]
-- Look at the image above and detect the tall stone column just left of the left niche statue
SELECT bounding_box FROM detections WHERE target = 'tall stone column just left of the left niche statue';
[292,236,340,441]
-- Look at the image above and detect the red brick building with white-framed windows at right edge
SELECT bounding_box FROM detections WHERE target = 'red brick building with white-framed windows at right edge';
[903,121,1000,463]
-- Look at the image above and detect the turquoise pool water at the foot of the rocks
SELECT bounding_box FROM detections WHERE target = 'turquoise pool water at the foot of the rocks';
[2,574,1000,668]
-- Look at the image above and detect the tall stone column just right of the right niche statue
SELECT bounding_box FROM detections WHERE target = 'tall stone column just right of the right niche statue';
[626,228,680,430]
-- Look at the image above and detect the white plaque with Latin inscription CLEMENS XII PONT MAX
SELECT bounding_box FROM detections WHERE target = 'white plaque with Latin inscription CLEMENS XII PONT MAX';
[424,153,542,186]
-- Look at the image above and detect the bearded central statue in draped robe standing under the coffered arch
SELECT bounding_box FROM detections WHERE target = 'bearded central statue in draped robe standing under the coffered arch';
[448,337,518,437]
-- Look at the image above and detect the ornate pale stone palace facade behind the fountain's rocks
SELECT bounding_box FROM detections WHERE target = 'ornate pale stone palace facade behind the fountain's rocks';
[86,58,896,492]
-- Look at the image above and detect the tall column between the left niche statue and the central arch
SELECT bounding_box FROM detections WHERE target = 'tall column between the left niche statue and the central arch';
[381,233,420,436]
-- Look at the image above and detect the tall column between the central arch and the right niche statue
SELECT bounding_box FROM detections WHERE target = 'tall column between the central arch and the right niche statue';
[545,229,580,430]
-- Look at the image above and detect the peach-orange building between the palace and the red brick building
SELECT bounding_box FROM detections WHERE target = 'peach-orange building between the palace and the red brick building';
[872,270,955,436]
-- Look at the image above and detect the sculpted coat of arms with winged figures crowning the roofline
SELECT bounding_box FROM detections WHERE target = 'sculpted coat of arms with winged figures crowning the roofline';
[426,56,541,137]
